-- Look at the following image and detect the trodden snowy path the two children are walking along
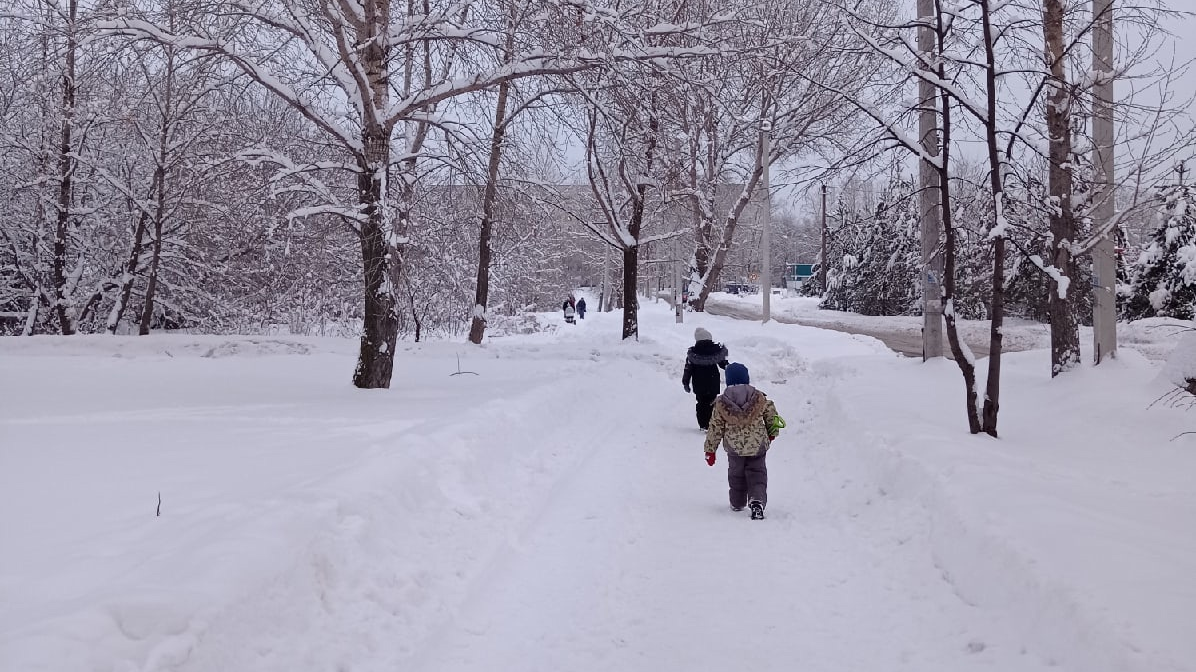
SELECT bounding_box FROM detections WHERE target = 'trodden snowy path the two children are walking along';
[404,341,1048,672]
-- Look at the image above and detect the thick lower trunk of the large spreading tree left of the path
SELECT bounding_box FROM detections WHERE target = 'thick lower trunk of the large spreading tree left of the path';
[353,127,399,390]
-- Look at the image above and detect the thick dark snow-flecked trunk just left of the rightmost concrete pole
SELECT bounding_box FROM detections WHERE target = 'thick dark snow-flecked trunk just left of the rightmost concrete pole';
[1043,0,1080,378]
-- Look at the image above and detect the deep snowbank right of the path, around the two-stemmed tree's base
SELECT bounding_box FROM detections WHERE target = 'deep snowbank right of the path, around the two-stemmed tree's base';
[827,349,1196,672]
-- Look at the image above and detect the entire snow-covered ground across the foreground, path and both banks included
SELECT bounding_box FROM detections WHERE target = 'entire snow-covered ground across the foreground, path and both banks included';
[0,300,1196,672]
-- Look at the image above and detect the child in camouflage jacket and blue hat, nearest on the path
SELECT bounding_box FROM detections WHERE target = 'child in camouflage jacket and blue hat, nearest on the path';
[702,362,785,520]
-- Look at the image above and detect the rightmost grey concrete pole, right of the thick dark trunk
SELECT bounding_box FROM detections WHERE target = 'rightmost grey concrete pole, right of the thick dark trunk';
[1092,0,1117,364]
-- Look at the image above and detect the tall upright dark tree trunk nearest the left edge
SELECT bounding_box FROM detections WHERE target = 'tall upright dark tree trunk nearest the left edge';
[51,0,79,336]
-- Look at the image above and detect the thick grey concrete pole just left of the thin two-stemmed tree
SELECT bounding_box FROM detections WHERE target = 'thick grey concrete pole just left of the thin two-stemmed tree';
[917,0,942,361]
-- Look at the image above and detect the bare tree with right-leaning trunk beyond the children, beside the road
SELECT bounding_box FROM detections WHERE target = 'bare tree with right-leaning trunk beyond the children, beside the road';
[661,2,877,310]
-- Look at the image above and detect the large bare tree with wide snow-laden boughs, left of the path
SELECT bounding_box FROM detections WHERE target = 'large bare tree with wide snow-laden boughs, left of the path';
[105,0,736,387]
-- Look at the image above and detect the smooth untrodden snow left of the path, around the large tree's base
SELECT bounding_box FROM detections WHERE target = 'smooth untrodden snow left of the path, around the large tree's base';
[0,336,622,672]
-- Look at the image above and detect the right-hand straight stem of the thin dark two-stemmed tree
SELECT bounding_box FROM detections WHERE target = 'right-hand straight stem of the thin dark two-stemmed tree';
[981,0,1006,436]
